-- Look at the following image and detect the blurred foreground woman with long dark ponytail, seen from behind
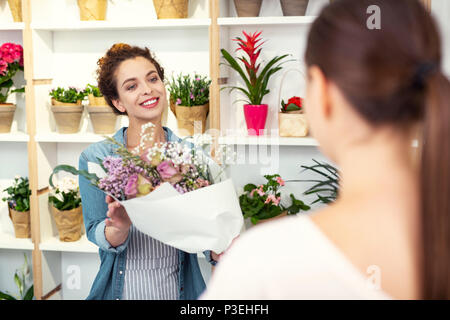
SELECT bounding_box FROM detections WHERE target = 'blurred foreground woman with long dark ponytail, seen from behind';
[201,0,450,299]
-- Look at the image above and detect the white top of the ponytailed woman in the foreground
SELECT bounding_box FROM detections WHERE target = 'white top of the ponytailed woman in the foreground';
[200,214,392,300]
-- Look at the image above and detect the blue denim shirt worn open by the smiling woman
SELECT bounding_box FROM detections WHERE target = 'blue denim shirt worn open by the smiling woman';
[78,127,214,300]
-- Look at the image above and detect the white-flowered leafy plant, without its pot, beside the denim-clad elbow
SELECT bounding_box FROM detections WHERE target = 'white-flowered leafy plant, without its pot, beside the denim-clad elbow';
[48,177,81,211]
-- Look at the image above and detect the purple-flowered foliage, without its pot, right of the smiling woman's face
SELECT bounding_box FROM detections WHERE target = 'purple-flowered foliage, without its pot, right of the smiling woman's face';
[167,73,211,107]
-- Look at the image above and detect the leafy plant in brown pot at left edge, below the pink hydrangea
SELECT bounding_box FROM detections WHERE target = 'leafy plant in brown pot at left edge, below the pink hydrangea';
[2,176,31,238]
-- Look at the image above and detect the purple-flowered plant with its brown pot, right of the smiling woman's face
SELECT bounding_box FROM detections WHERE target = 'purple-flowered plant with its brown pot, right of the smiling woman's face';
[168,74,211,136]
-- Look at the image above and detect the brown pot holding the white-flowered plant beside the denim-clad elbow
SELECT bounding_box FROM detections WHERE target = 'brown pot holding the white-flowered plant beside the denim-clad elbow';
[51,206,83,242]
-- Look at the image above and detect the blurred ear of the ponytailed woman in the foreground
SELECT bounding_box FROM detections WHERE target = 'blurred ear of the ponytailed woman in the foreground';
[309,66,332,119]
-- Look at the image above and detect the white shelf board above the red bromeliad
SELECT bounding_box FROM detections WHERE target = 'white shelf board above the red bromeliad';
[217,16,316,26]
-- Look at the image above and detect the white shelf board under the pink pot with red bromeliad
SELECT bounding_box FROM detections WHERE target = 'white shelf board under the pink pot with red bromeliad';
[219,136,319,146]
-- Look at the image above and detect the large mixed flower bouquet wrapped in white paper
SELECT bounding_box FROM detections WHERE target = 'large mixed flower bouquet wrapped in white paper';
[49,123,243,253]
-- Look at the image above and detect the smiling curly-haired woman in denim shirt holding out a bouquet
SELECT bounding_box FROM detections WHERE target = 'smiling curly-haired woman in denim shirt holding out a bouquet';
[79,44,218,300]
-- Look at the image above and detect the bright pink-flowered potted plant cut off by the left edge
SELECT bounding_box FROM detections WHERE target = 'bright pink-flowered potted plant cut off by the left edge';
[0,43,25,133]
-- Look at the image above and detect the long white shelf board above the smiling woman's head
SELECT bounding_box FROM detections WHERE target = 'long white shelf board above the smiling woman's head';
[31,18,211,31]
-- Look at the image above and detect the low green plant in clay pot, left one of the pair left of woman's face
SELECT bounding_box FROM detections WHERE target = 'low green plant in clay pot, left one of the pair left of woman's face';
[49,87,86,133]
